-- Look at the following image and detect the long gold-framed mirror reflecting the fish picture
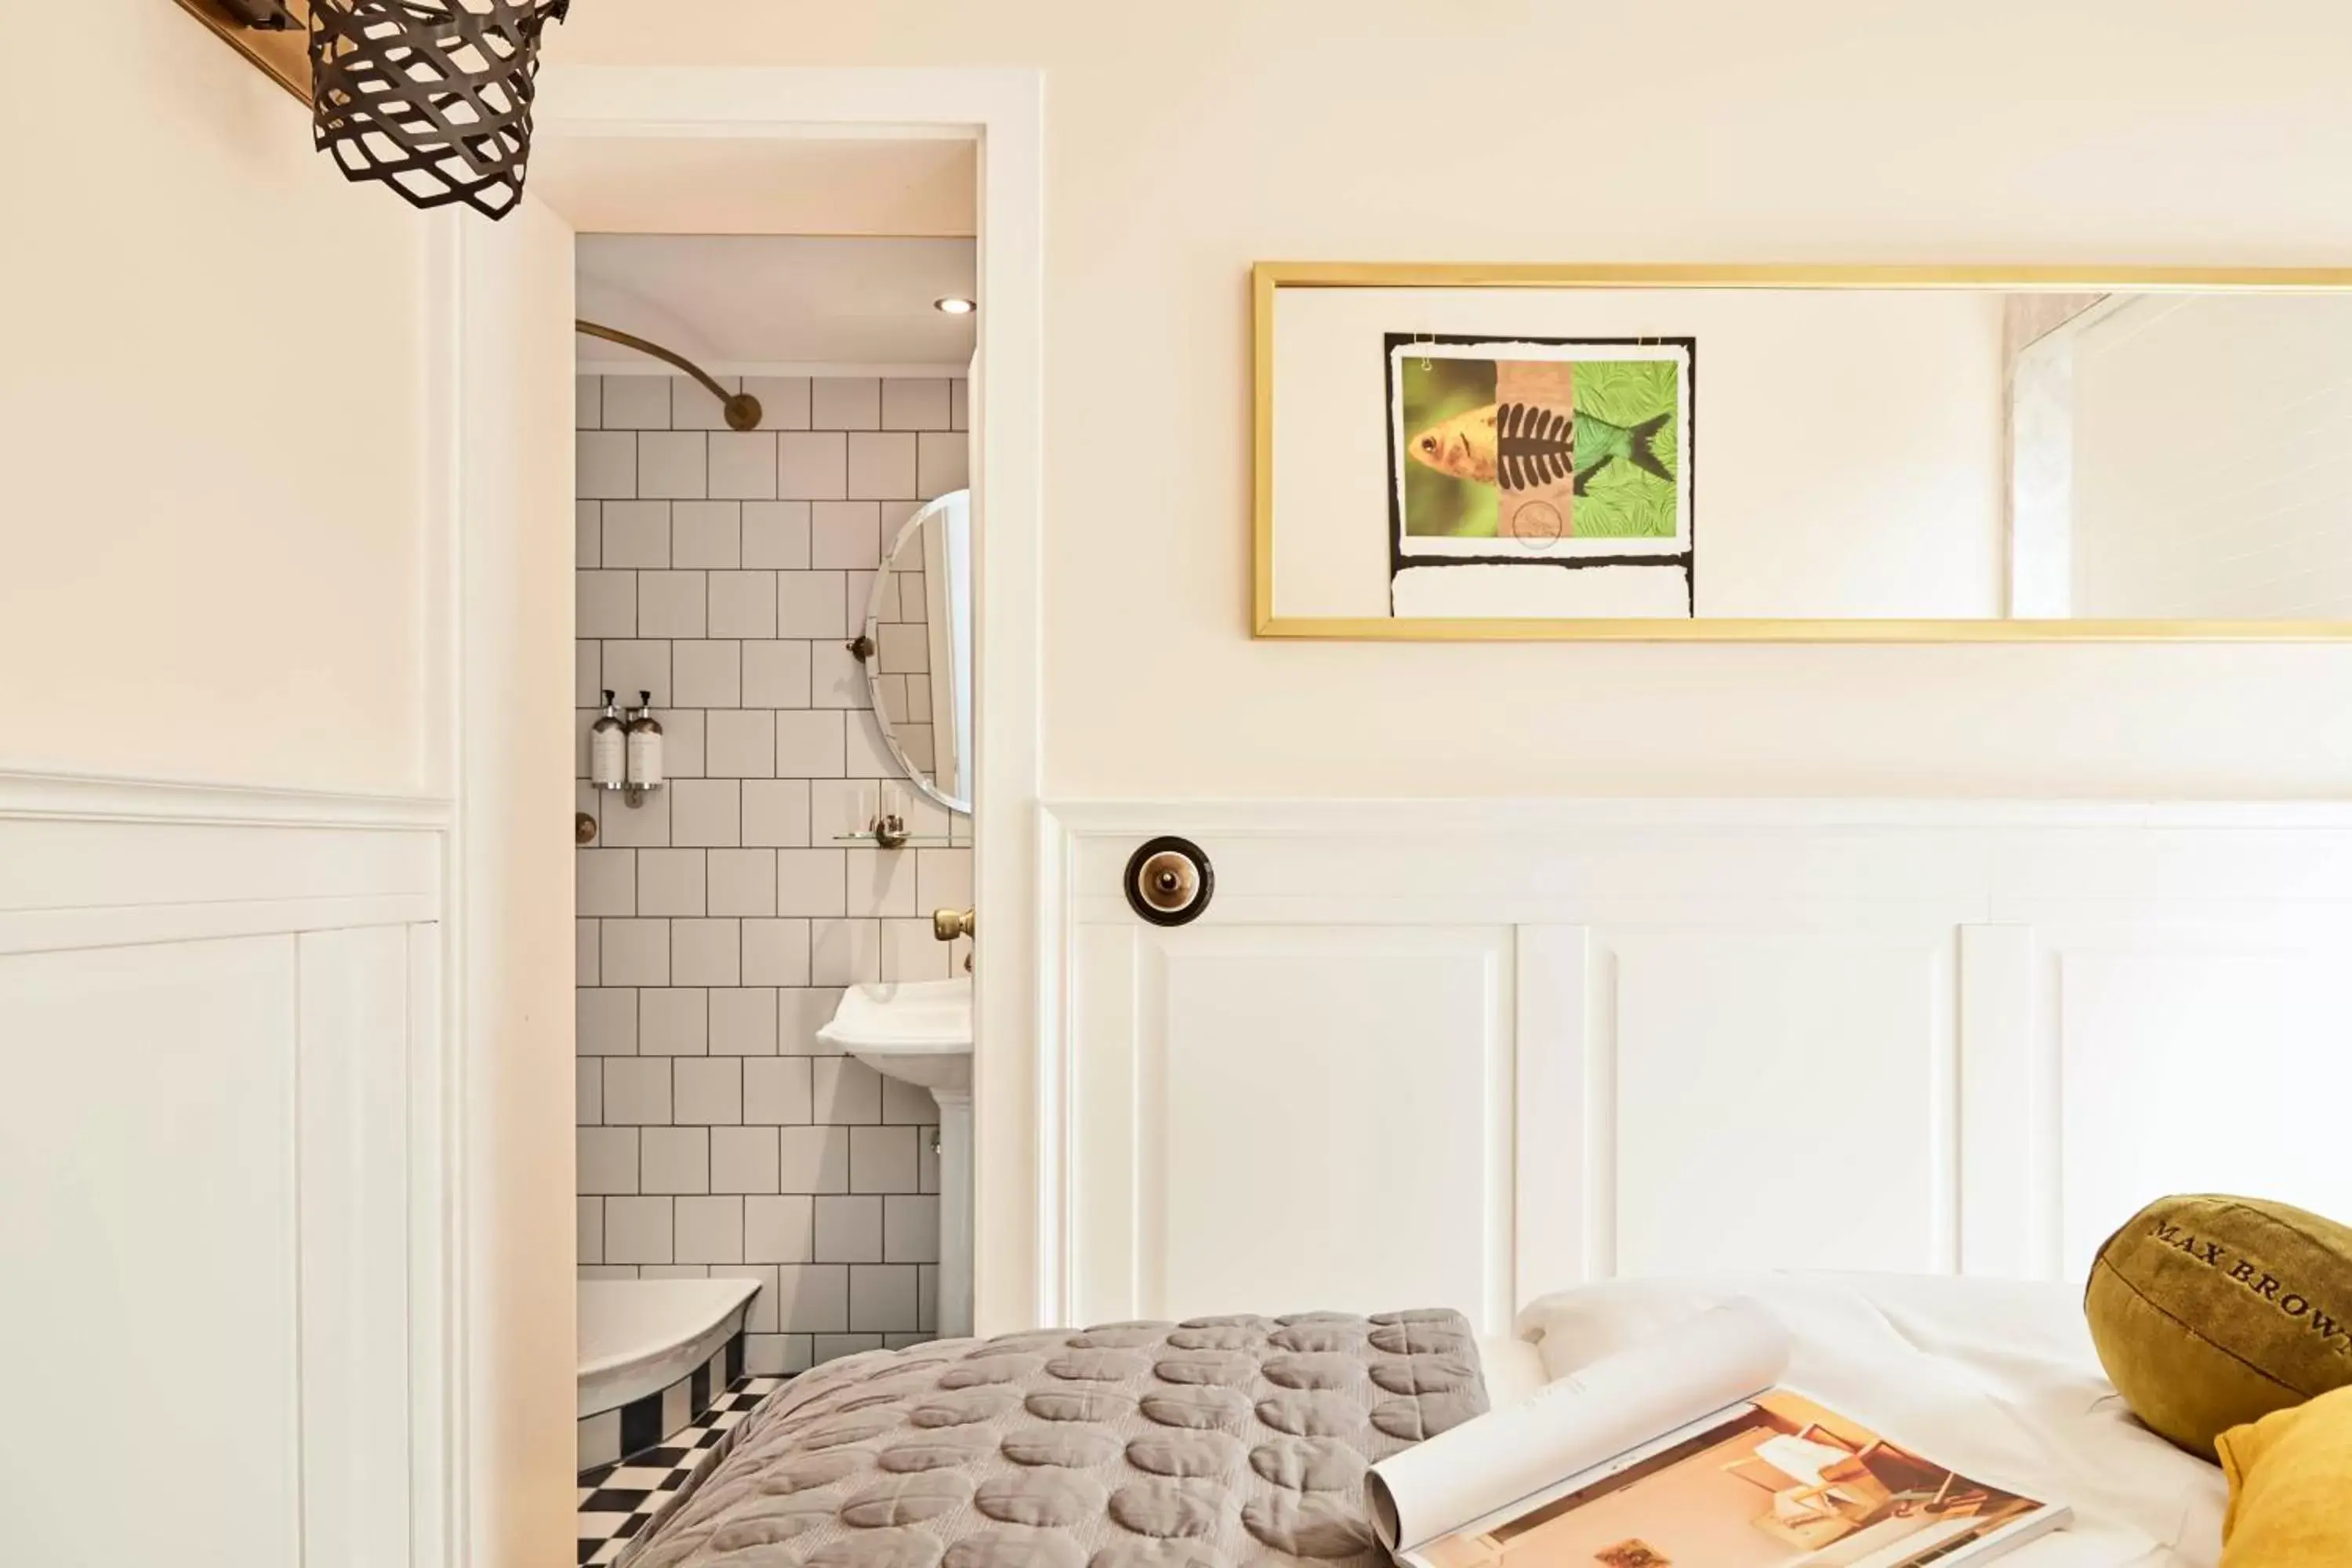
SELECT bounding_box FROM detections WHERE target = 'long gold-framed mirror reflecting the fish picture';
[1251,261,2352,642]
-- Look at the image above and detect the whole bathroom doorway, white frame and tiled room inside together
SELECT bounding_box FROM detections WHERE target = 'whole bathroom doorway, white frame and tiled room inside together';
[452,71,1047,1554]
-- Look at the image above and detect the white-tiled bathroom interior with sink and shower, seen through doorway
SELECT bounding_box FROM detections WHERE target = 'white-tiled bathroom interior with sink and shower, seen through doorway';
[574,233,978,1472]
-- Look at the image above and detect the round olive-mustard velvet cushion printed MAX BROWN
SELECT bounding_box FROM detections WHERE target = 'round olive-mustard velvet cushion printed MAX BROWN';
[2084,1196,2352,1457]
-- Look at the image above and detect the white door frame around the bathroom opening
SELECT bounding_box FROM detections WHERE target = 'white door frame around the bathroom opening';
[442,66,1058,1568]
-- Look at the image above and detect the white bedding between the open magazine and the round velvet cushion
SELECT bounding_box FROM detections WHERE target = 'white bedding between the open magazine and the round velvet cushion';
[1479,1274,2227,1568]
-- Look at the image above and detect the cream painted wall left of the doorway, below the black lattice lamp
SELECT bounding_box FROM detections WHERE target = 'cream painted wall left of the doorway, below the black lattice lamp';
[0,0,445,792]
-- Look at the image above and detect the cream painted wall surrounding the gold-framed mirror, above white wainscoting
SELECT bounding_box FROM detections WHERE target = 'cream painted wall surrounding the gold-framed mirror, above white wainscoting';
[553,0,2352,797]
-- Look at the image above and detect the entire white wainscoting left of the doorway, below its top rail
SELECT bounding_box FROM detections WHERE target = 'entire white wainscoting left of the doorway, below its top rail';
[0,776,449,1568]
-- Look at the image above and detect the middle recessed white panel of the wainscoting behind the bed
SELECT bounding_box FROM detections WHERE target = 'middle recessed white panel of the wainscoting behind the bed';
[1604,928,1959,1274]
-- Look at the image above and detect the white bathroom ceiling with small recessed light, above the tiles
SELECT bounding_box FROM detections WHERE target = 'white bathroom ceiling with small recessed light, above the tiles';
[579,235,978,374]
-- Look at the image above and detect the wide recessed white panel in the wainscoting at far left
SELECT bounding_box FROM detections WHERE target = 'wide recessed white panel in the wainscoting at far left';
[0,938,303,1568]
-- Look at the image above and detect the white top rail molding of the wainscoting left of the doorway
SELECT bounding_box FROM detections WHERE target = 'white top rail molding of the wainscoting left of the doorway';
[0,769,454,832]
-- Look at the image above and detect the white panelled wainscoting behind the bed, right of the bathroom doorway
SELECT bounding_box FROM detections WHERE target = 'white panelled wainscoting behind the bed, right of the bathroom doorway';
[1042,801,2352,1328]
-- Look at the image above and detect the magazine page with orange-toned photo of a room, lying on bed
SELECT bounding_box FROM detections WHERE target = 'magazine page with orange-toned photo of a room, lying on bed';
[1402,1389,2067,1568]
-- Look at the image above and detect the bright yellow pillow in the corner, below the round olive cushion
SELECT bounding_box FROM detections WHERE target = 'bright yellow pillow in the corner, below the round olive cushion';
[2213,1387,2352,1568]
